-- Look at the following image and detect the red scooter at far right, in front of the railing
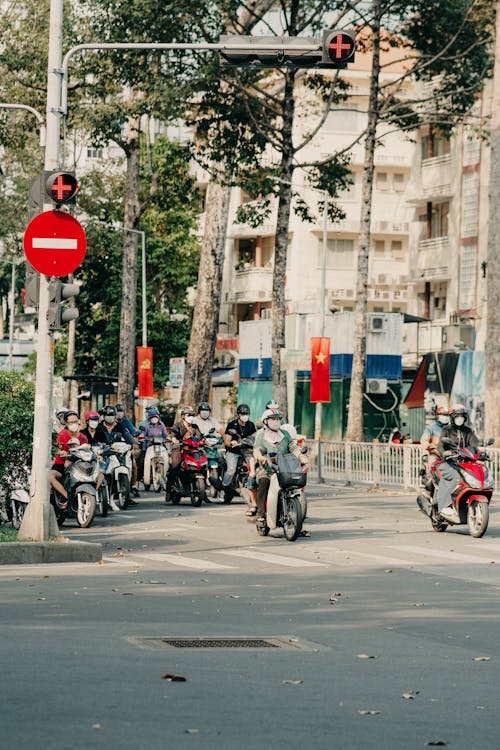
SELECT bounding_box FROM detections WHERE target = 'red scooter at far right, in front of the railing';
[417,438,495,538]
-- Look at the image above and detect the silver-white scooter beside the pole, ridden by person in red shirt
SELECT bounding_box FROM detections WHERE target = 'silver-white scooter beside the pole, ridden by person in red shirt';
[50,444,100,528]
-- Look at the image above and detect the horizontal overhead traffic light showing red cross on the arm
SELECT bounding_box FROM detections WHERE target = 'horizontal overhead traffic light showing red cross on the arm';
[220,30,356,69]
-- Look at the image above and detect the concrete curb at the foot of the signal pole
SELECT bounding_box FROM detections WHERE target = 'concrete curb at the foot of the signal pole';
[0,542,102,565]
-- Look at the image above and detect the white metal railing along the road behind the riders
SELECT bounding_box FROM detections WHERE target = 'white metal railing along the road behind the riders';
[307,440,500,490]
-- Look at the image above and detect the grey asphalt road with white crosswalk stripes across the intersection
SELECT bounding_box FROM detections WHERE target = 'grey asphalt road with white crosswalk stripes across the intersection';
[0,484,500,750]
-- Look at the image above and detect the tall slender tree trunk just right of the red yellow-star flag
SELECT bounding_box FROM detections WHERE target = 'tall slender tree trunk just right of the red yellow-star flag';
[346,0,381,442]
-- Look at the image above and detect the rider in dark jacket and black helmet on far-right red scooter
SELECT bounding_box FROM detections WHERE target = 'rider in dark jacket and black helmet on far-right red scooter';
[436,404,479,519]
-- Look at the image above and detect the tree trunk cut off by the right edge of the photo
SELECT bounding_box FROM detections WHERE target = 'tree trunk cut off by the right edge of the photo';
[484,2,500,438]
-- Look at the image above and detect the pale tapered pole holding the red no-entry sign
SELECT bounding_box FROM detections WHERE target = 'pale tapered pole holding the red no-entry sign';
[18,0,63,541]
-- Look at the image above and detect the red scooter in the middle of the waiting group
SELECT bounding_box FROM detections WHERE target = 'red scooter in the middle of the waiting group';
[165,435,208,507]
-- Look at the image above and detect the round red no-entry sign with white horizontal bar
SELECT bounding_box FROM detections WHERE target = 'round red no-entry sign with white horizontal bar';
[24,211,87,276]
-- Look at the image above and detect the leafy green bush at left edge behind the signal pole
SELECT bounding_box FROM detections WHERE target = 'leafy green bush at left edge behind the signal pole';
[0,371,35,490]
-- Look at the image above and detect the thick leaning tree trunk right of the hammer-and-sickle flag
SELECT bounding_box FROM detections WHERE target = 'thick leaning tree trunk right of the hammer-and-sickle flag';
[180,182,229,407]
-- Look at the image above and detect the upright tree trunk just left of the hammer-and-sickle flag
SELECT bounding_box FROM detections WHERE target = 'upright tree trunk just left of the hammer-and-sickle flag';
[118,118,140,414]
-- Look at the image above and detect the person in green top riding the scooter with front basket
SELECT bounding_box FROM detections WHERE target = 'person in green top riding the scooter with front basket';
[253,409,307,529]
